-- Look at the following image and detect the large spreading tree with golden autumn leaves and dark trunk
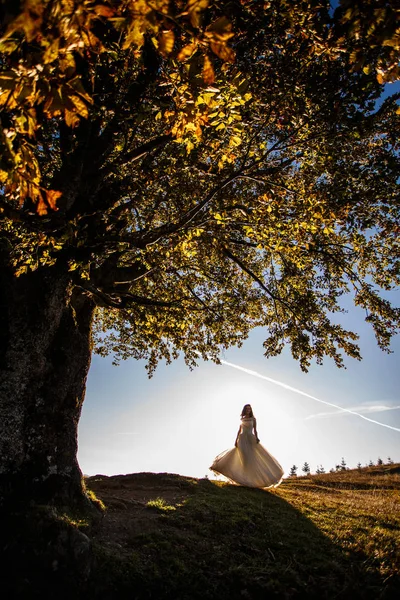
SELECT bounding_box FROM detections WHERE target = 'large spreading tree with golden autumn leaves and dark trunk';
[0,0,400,505]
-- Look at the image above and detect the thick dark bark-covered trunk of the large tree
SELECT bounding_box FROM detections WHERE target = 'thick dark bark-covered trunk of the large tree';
[0,263,94,508]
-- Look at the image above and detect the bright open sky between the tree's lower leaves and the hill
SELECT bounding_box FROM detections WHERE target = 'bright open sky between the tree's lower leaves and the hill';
[78,282,400,477]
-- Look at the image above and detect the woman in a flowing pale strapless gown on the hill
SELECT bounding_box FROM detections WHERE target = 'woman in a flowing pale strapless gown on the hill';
[210,404,283,488]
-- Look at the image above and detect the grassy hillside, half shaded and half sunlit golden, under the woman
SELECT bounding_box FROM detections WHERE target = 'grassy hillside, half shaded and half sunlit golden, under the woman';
[86,465,400,600]
